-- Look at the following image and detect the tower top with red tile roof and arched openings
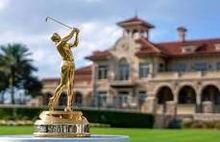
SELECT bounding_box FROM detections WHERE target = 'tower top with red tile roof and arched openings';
[117,16,154,40]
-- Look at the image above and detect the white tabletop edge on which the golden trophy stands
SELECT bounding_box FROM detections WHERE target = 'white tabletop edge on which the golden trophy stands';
[0,135,129,142]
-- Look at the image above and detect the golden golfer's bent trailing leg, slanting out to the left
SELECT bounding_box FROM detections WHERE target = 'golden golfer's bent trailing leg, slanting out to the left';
[48,65,68,111]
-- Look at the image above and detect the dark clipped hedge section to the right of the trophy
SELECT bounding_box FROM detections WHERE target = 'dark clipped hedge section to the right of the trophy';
[82,110,154,128]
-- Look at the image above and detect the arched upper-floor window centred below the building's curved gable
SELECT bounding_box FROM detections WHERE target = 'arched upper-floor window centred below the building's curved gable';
[119,59,129,80]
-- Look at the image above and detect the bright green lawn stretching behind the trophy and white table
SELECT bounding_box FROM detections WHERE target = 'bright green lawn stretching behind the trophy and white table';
[0,126,220,142]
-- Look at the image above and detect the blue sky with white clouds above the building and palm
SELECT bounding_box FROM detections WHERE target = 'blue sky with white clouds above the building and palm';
[0,0,220,79]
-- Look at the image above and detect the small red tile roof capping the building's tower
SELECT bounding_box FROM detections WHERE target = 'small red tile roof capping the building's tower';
[117,16,155,28]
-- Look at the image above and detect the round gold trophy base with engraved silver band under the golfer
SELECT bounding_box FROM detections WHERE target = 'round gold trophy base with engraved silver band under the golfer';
[34,111,90,137]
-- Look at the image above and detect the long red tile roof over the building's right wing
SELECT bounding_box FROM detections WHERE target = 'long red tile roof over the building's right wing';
[136,38,220,57]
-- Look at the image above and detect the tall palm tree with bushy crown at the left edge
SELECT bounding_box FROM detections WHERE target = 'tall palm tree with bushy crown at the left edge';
[0,44,36,104]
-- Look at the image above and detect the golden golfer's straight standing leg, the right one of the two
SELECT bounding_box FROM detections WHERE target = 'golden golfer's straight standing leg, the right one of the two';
[65,63,74,111]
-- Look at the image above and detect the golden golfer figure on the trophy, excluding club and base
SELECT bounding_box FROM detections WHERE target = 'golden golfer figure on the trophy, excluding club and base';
[48,28,79,111]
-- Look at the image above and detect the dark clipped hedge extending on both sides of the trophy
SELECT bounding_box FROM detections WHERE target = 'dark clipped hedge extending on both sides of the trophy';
[0,107,154,128]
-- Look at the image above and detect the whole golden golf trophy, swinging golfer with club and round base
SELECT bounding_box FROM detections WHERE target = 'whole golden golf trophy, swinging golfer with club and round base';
[34,17,90,137]
